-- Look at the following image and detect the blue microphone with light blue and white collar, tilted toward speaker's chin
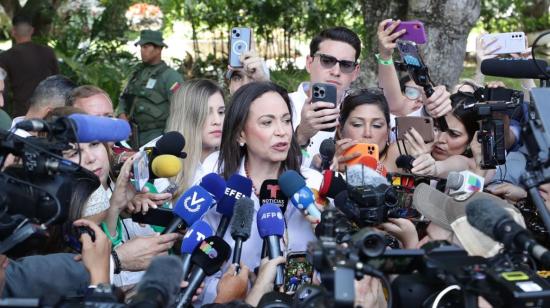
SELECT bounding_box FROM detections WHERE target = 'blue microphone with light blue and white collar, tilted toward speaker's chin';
[279,170,321,220]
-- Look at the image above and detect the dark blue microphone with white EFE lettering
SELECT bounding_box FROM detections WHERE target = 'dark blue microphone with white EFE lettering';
[216,174,252,237]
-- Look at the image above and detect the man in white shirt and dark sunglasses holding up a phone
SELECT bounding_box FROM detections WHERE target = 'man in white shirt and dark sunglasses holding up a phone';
[290,27,361,167]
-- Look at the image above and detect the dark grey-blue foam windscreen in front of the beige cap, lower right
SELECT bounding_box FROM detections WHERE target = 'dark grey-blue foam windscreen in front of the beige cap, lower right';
[466,198,512,238]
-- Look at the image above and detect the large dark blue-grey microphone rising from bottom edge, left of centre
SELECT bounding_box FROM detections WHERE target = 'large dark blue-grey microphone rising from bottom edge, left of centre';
[128,256,182,308]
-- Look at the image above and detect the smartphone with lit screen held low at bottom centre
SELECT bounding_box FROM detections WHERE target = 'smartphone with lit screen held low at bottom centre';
[285,251,313,293]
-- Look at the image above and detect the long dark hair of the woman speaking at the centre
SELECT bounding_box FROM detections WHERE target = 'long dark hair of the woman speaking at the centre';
[218,82,302,179]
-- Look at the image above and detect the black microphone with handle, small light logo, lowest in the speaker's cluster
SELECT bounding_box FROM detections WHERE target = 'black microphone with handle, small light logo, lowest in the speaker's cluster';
[177,236,231,307]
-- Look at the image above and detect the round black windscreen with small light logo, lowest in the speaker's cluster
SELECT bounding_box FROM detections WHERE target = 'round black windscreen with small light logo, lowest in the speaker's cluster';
[191,236,231,276]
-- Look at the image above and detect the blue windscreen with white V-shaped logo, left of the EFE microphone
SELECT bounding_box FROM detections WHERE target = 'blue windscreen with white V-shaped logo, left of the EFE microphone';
[174,186,214,226]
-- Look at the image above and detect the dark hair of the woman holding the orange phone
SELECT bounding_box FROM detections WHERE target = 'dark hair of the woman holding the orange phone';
[338,88,390,127]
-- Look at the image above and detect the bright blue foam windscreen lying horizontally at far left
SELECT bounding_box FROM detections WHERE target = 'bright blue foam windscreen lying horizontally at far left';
[69,114,131,143]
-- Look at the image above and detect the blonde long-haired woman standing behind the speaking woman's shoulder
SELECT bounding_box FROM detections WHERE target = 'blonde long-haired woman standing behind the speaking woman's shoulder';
[166,79,225,198]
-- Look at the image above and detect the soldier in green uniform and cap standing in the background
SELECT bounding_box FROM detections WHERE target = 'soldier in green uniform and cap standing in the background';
[116,30,183,148]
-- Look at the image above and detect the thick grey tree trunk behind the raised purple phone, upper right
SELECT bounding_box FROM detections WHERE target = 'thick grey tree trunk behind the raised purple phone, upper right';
[407,0,481,87]
